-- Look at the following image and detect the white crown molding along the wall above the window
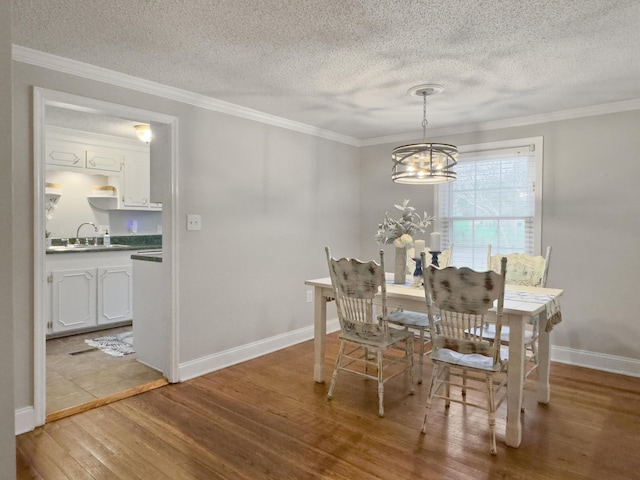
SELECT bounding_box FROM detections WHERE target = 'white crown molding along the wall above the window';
[360,98,640,147]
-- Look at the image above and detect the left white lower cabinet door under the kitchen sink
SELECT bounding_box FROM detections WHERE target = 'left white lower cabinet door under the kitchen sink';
[51,268,97,333]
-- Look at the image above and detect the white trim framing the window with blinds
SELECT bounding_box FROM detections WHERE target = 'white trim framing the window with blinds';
[433,136,544,255]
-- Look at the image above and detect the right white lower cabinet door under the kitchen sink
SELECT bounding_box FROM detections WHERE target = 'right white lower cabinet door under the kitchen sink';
[98,265,133,325]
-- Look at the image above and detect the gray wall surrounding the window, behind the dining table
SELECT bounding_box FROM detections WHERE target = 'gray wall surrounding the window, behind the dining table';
[360,111,640,376]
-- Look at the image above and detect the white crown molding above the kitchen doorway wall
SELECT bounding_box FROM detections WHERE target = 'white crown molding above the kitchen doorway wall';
[12,44,361,147]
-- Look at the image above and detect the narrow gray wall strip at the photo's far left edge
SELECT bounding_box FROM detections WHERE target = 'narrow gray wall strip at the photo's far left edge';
[0,1,16,479]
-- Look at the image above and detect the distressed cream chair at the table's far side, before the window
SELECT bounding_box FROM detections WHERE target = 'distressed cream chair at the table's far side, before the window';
[483,244,551,377]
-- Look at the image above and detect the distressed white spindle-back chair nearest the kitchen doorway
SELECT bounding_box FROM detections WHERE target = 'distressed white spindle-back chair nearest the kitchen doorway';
[325,247,415,417]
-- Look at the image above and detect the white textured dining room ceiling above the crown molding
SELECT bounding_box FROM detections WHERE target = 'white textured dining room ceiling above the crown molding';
[13,0,640,139]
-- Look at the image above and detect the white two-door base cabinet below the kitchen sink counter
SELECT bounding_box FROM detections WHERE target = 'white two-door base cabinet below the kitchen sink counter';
[45,251,133,336]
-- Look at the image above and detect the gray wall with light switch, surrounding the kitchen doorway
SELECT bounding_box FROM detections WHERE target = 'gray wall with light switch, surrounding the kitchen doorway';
[13,62,360,409]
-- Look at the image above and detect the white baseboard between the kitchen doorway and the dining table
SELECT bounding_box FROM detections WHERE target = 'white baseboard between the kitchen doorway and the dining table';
[178,319,340,382]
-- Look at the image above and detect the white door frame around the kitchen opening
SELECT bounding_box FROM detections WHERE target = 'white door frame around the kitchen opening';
[33,87,179,426]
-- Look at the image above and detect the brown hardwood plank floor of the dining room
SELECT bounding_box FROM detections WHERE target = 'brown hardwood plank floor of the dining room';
[16,334,640,480]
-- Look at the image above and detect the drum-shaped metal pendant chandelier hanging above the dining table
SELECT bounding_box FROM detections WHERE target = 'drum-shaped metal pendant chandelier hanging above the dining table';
[391,84,458,185]
